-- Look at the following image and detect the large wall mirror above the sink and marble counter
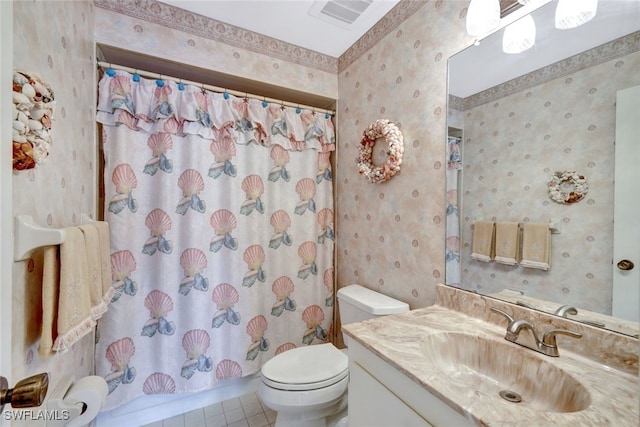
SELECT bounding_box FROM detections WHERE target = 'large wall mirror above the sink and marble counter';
[446,0,640,335]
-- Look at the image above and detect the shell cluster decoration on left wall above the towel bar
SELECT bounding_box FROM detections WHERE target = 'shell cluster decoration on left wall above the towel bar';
[13,71,55,170]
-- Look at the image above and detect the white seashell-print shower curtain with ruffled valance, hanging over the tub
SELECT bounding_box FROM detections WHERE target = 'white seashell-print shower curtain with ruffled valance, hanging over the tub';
[96,69,335,410]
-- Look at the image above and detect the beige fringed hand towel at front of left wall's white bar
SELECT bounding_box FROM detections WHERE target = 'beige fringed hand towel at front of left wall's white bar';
[53,227,96,352]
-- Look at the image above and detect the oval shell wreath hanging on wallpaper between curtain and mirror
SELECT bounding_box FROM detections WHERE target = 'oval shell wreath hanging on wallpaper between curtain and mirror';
[356,119,404,184]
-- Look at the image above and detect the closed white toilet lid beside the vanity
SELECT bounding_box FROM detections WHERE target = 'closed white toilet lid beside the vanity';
[262,344,349,390]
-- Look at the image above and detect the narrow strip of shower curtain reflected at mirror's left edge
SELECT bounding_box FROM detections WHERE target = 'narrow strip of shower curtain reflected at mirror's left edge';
[445,137,462,287]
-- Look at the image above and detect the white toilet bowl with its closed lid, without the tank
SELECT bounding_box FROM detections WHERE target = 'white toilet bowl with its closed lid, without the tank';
[258,344,349,427]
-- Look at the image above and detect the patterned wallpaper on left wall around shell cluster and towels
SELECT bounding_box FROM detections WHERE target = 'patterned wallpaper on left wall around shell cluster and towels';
[12,0,96,387]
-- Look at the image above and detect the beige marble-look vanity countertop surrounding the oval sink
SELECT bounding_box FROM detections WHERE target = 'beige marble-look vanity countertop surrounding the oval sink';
[342,305,640,427]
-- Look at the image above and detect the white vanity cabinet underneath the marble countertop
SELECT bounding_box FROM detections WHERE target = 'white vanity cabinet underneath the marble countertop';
[348,339,473,427]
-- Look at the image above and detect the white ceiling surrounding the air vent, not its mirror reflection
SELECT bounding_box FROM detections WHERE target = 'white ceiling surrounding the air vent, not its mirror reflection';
[162,0,399,58]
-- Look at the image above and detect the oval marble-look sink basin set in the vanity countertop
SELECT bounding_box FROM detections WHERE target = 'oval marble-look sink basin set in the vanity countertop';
[420,332,591,413]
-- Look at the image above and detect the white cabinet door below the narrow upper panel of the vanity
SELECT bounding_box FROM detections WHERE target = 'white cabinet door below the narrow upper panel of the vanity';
[349,363,431,427]
